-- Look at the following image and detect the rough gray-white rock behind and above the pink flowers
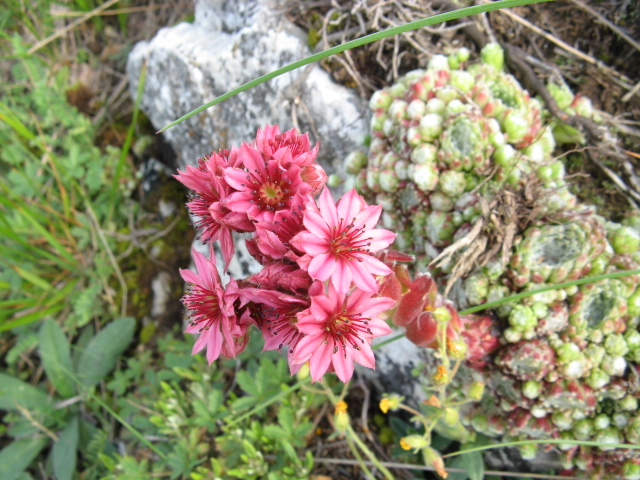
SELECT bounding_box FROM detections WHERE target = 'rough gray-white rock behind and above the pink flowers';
[127,0,367,173]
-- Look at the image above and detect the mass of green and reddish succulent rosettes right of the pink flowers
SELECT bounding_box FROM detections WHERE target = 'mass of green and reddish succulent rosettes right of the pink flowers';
[346,44,640,479]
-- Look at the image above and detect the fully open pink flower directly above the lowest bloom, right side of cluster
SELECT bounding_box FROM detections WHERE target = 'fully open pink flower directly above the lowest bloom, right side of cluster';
[290,188,396,293]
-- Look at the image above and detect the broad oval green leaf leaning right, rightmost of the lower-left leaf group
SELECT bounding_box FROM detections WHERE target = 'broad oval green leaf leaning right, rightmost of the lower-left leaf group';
[78,317,136,387]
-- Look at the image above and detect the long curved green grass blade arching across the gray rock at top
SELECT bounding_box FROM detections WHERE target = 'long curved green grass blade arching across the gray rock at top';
[157,0,552,133]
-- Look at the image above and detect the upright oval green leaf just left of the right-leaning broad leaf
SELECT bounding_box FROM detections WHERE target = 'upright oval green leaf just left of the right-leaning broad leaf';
[39,319,76,398]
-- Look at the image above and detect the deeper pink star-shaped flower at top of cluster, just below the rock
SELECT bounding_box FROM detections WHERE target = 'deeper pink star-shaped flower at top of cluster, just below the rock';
[224,144,312,221]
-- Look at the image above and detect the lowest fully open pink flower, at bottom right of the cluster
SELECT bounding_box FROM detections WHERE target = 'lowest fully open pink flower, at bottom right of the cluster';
[293,282,396,383]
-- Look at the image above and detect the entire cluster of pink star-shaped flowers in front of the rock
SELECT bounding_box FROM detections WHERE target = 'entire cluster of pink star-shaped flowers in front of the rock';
[176,126,399,382]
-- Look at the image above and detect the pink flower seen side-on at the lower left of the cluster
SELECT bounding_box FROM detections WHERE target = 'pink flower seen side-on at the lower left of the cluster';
[180,248,248,364]
